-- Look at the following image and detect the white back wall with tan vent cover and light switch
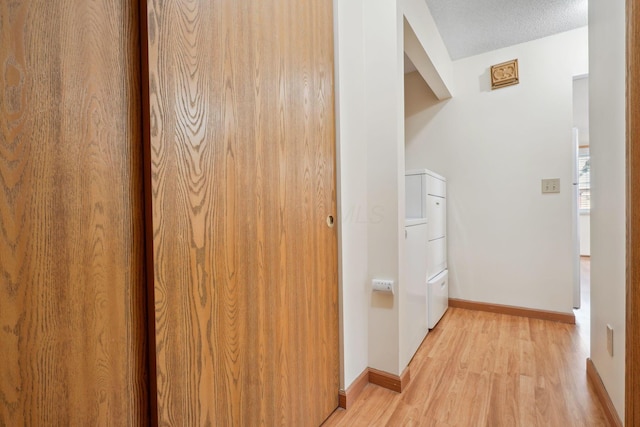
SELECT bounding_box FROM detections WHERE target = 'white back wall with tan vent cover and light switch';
[405,28,588,313]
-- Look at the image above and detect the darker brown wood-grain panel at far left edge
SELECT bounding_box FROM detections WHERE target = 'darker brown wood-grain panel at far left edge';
[0,0,148,426]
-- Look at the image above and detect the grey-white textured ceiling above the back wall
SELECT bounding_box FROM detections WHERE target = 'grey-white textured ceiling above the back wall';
[426,0,588,60]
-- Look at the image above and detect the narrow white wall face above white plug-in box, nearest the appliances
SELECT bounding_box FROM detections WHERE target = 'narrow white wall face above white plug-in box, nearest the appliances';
[363,0,404,375]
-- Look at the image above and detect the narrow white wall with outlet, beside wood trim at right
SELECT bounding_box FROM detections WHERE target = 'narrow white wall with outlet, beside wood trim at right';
[589,0,625,419]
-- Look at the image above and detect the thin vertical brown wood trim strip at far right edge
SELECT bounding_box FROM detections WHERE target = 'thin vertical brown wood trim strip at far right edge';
[625,0,640,426]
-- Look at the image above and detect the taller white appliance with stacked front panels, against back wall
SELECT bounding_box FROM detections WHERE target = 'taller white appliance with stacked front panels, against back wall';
[405,169,449,328]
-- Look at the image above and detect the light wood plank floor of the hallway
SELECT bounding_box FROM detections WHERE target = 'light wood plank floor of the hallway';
[324,302,607,427]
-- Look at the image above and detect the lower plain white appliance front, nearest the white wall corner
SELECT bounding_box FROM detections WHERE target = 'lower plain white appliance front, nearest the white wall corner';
[403,218,429,363]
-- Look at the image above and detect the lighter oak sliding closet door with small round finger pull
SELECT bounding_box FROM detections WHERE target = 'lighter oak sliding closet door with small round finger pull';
[146,0,339,426]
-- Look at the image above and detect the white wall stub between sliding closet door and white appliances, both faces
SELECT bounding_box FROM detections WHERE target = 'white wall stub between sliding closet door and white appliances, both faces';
[334,0,451,389]
